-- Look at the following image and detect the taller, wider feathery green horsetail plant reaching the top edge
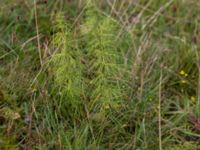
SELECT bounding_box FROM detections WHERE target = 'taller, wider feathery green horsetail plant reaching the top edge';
[82,1,122,111]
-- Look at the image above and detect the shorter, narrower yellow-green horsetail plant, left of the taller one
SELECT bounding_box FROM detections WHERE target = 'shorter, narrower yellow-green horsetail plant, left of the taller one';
[52,13,83,116]
